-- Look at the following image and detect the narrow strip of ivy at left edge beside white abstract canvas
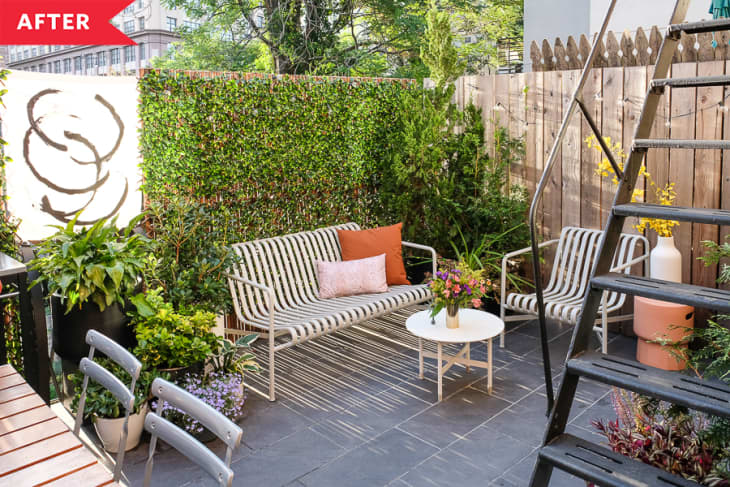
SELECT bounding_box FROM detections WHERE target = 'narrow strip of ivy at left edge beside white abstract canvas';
[0,69,23,371]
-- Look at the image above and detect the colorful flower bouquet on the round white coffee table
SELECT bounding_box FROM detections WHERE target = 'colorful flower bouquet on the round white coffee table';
[429,261,491,317]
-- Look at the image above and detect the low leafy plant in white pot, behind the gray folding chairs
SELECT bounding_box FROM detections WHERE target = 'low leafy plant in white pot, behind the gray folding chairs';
[68,357,170,419]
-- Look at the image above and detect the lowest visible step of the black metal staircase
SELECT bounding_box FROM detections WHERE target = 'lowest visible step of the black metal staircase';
[537,434,700,487]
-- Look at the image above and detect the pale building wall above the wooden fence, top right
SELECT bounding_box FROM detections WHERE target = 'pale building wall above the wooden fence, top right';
[524,0,712,71]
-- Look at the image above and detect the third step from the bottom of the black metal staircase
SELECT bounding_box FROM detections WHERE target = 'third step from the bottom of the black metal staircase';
[591,272,730,312]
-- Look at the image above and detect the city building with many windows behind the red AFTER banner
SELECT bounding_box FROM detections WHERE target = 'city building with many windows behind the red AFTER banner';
[5,0,193,75]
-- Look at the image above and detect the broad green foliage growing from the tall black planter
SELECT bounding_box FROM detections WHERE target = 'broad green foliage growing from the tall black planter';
[30,213,150,313]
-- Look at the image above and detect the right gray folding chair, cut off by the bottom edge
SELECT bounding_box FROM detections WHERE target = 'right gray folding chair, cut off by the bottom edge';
[144,377,243,487]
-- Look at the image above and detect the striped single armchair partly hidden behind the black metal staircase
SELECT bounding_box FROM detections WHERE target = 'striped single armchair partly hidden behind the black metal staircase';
[500,227,649,353]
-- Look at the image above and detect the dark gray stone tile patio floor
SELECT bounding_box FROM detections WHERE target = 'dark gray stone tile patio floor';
[118,307,635,487]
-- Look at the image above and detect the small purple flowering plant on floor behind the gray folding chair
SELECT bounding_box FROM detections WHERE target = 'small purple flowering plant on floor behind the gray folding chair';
[152,371,244,434]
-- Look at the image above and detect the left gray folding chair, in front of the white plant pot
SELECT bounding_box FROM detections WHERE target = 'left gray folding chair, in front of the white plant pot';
[74,330,142,482]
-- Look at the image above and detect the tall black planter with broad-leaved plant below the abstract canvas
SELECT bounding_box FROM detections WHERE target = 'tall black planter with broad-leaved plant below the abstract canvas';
[30,215,149,363]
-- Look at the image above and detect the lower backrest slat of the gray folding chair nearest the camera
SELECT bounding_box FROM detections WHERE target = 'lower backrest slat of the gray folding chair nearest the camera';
[144,413,233,486]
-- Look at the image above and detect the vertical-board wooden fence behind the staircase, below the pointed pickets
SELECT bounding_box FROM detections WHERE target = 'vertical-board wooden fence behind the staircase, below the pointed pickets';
[456,61,730,306]
